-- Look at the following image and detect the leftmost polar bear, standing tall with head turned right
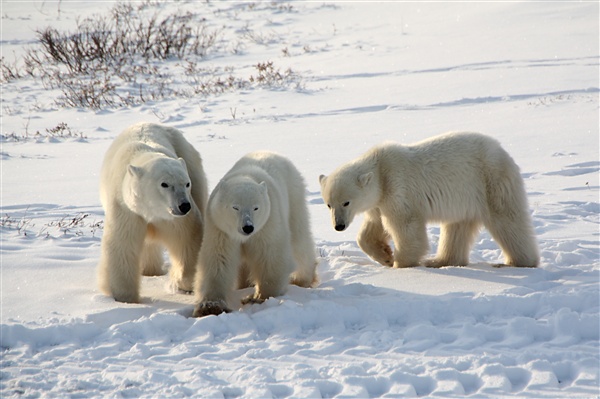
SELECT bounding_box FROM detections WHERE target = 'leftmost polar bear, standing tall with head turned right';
[98,123,208,302]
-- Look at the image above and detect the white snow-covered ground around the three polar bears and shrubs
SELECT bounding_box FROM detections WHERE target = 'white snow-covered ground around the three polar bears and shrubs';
[0,1,600,398]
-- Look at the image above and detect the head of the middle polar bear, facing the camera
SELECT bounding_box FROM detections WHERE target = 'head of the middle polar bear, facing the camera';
[208,176,271,242]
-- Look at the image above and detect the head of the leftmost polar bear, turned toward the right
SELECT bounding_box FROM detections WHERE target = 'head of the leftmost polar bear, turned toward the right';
[123,157,192,222]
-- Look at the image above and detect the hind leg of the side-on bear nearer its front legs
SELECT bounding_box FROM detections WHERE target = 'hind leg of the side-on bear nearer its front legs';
[425,220,480,267]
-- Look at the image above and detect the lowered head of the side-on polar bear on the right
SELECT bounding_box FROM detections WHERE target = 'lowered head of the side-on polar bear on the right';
[319,168,379,231]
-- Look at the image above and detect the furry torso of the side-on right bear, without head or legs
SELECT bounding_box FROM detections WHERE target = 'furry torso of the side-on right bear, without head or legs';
[379,133,526,220]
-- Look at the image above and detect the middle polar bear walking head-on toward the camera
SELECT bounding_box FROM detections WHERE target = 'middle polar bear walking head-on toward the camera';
[194,152,317,317]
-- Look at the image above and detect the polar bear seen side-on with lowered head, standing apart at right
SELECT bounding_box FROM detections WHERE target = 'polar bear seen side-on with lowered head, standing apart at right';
[319,133,539,268]
